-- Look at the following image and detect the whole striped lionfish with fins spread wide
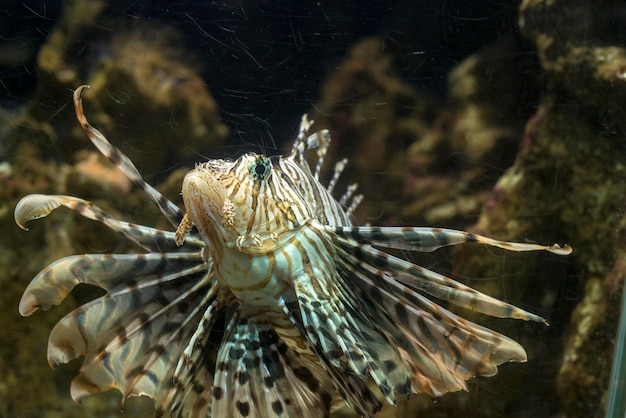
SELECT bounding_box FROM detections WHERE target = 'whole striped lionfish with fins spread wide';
[15,86,571,417]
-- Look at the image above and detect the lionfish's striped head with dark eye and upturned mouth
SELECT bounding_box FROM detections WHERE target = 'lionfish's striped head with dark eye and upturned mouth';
[182,153,310,251]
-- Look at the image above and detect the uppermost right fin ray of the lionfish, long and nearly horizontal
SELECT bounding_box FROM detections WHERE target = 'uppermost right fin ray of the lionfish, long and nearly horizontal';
[332,226,572,255]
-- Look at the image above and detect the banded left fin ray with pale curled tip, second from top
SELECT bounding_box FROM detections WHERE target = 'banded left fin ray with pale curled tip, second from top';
[14,194,204,252]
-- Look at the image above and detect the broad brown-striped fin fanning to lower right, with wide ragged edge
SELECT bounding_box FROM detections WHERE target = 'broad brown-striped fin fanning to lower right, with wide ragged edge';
[332,245,526,396]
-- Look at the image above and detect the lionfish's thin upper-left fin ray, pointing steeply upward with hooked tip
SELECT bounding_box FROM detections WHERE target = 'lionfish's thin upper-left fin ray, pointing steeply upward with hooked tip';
[74,85,185,228]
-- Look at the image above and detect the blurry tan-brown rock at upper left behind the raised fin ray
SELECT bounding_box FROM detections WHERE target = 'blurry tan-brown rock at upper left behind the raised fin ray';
[10,0,228,174]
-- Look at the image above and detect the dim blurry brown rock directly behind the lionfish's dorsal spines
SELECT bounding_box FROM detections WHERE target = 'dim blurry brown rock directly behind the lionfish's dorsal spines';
[312,38,437,224]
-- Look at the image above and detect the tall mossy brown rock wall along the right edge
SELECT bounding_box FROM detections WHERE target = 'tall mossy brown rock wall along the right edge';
[518,0,626,417]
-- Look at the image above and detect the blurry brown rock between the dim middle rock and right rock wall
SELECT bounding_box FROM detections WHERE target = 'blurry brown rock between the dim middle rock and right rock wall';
[401,39,538,229]
